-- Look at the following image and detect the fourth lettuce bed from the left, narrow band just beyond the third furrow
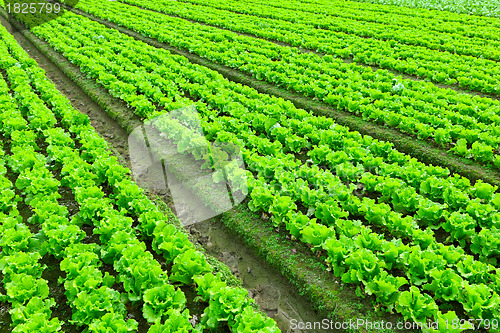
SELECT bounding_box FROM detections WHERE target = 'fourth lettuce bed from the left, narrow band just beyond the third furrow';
[118,0,498,97]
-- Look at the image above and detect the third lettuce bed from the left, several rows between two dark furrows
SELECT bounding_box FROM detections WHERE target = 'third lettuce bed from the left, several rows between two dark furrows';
[70,0,500,164]
